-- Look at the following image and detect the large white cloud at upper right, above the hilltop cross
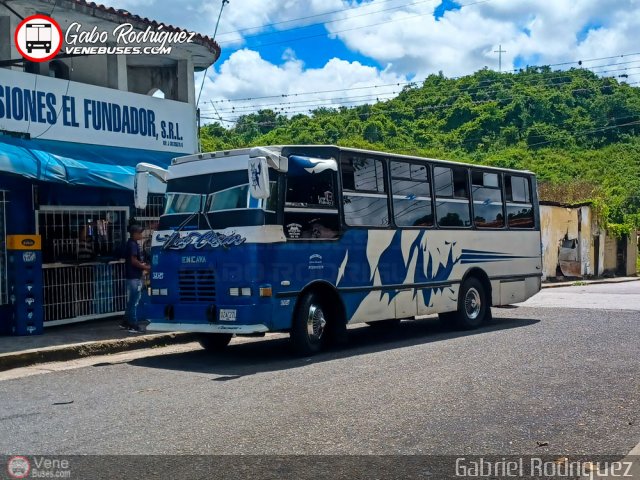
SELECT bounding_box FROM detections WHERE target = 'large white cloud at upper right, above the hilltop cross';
[328,0,640,76]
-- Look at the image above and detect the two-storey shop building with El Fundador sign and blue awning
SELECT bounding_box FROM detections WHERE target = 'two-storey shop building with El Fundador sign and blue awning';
[0,0,220,334]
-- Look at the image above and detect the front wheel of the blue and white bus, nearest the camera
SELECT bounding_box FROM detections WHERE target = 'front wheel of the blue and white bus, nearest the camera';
[290,293,327,355]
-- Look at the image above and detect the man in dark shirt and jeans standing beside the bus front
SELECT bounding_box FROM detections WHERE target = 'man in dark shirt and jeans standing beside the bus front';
[120,225,150,333]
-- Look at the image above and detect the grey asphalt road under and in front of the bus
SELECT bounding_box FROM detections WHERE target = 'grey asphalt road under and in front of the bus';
[0,282,640,455]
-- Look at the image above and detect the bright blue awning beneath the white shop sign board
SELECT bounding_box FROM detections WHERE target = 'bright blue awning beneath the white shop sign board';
[0,135,181,191]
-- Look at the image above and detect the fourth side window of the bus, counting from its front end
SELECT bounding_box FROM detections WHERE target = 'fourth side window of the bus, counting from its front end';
[433,167,471,227]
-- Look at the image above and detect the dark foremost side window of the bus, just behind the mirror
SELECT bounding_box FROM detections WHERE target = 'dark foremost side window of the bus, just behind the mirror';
[284,158,340,240]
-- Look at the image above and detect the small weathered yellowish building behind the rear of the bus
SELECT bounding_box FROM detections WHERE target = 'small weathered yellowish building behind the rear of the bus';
[540,202,638,280]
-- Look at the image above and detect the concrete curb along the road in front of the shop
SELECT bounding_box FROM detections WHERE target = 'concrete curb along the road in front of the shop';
[0,332,198,372]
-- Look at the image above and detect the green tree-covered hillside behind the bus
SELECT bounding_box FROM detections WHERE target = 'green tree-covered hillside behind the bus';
[201,68,640,233]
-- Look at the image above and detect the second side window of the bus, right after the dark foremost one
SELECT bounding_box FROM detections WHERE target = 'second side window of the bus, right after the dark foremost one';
[341,157,389,227]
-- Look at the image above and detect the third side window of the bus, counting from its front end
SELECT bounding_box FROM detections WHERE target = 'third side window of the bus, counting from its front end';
[390,162,433,227]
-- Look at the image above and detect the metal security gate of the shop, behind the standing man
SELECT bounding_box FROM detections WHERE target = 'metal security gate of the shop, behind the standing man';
[36,206,129,327]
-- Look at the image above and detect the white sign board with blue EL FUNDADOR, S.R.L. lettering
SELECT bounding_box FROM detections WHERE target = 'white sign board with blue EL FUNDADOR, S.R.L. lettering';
[0,68,197,154]
